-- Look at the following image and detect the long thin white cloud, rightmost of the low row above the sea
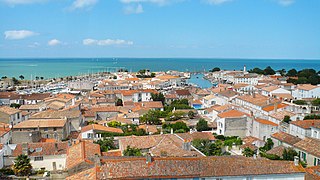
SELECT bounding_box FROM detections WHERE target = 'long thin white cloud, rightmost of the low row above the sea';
[82,38,133,46]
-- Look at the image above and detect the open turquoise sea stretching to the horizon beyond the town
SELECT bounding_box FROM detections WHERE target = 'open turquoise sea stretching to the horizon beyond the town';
[0,58,320,79]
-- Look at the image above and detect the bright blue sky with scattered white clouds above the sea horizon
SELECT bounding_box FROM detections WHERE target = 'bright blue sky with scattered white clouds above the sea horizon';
[0,0,320,59]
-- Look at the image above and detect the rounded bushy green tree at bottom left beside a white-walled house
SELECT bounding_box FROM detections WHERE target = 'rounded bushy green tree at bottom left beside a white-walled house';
[12,154,32,176]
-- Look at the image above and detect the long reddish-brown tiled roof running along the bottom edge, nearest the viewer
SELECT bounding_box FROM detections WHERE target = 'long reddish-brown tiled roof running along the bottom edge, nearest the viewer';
[100,156,305,179]
